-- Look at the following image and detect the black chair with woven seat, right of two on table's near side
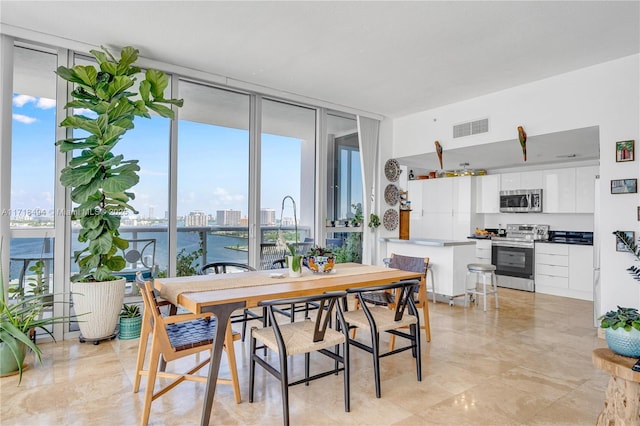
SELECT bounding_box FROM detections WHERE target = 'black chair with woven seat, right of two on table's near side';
[344,280,422,398]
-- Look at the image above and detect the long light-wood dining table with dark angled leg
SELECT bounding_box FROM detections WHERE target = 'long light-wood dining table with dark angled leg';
[154,263,421,425]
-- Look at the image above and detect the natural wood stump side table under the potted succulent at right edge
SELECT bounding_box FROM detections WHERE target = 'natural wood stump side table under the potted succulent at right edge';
[591,348,640,426]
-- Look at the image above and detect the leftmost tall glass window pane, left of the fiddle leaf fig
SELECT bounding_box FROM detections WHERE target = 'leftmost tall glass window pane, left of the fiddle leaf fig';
[9,46,62,340]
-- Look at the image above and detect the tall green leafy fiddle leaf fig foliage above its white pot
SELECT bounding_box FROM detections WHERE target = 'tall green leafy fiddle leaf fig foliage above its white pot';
[56,46,183,281]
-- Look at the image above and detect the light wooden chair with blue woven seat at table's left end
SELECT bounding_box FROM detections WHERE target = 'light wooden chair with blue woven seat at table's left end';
[133,281,241,425]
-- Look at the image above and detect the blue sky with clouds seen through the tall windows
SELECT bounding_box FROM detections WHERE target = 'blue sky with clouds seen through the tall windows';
[11,94,301,218]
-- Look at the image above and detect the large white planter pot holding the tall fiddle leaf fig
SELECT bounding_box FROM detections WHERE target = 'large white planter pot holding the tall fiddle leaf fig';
[71,278,125,340]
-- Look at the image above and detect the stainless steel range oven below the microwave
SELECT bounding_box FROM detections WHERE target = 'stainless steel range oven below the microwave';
[491,224,549,291]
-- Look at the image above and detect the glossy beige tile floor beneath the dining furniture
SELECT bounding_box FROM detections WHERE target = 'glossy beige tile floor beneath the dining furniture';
[0,289,608,426]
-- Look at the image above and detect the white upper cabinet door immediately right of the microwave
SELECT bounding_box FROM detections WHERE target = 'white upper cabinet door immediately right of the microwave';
[542,168,576,213]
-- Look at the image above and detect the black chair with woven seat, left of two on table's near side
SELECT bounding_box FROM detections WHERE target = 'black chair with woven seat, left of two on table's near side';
[249,291,350,425]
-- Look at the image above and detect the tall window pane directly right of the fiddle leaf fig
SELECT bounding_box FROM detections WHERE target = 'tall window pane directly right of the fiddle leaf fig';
[176,81,250,275]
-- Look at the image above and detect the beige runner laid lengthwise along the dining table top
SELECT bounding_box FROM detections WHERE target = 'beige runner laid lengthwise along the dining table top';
[160,264,393,305]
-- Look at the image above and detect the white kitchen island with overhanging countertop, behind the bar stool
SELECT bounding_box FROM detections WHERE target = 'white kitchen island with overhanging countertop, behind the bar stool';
[380,238,476,305]
